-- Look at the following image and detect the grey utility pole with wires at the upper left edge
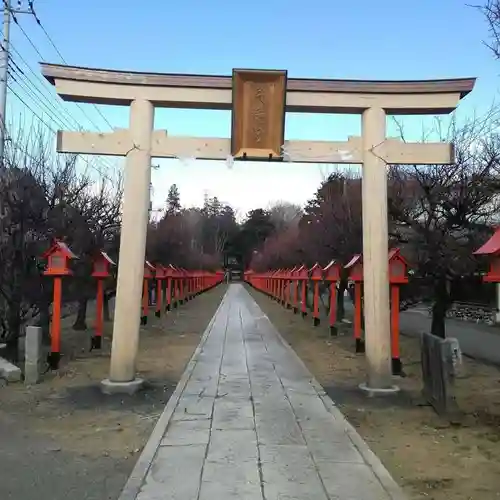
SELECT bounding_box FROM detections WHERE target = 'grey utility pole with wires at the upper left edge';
[0,0,35,166]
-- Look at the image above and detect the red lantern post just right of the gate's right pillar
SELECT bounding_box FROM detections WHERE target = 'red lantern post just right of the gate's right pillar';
[389,248,408,375]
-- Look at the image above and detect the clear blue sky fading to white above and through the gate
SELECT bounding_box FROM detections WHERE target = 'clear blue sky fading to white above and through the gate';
[3,0,500,216]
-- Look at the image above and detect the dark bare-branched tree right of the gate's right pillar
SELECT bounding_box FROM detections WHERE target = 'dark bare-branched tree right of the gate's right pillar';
[389,115,500,337]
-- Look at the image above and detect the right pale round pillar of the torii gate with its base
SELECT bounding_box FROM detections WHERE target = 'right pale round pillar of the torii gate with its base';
[362,108,395,393]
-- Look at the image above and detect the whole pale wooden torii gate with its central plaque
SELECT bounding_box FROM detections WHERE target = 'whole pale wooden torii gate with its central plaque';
[41,64,475,392]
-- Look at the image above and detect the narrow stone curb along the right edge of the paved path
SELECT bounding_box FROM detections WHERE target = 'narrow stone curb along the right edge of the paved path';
[246,290,407,500]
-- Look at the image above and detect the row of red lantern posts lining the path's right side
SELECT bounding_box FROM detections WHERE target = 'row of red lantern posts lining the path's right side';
[244,248,408,375]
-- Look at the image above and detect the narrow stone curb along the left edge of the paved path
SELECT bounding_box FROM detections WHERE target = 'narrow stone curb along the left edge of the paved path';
[118,291,227,500]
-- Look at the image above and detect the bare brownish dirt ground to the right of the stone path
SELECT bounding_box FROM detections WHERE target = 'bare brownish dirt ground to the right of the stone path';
[250,289,500,500]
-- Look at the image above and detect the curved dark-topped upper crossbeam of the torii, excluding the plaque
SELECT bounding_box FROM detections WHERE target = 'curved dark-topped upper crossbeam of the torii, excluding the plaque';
[41,63,475,115]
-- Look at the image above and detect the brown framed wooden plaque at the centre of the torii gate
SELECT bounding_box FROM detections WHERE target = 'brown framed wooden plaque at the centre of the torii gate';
[231,69,287,160]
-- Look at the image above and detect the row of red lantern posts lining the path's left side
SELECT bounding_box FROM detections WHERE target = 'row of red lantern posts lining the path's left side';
[43,240,224,370]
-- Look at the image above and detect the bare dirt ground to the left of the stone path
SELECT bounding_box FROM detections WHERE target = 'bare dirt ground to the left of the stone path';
[0,286,225,500]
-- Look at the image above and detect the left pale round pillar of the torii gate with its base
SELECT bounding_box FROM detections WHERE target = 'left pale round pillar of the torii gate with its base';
[102,100,154,393]
